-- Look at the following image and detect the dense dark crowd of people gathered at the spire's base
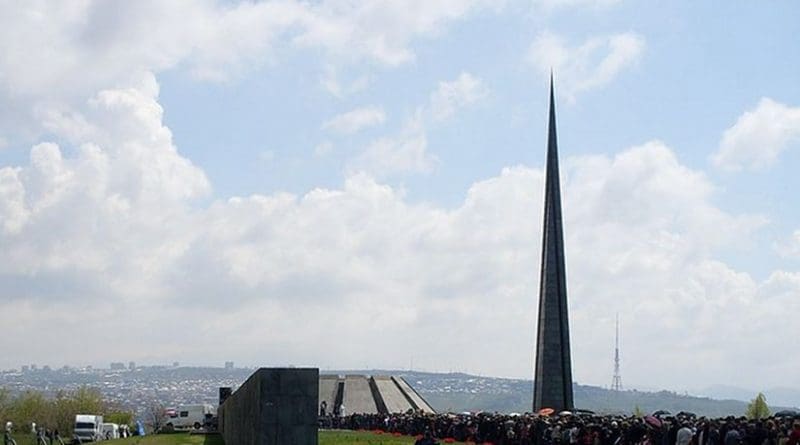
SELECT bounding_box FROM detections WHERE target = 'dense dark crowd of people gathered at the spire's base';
[320,412,800,445]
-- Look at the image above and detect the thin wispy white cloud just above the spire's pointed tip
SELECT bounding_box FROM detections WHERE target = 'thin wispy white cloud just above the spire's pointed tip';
[528,32,645,100]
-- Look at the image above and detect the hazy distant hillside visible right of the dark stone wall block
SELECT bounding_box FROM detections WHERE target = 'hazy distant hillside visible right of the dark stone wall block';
[329,370,796,417]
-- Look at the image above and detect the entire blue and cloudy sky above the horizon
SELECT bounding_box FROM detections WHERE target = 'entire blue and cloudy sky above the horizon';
[0,0,800,390]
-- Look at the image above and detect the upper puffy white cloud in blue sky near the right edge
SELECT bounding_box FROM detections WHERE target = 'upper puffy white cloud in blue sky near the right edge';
[711,97,800,171]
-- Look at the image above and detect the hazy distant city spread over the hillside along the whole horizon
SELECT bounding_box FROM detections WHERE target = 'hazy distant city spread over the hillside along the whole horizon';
[0,361,800,416]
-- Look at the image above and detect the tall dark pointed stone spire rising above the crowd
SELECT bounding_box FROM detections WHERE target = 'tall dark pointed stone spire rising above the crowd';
[533,73,574,412]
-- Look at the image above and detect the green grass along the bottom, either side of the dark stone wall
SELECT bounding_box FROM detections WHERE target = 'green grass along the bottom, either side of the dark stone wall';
[7,431,438,445]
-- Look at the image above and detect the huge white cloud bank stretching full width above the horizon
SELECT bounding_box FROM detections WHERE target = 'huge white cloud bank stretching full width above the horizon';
[0,93,800,386]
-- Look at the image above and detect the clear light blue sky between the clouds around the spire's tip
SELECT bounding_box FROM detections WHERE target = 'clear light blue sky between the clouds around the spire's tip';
[148,2,800,278]
